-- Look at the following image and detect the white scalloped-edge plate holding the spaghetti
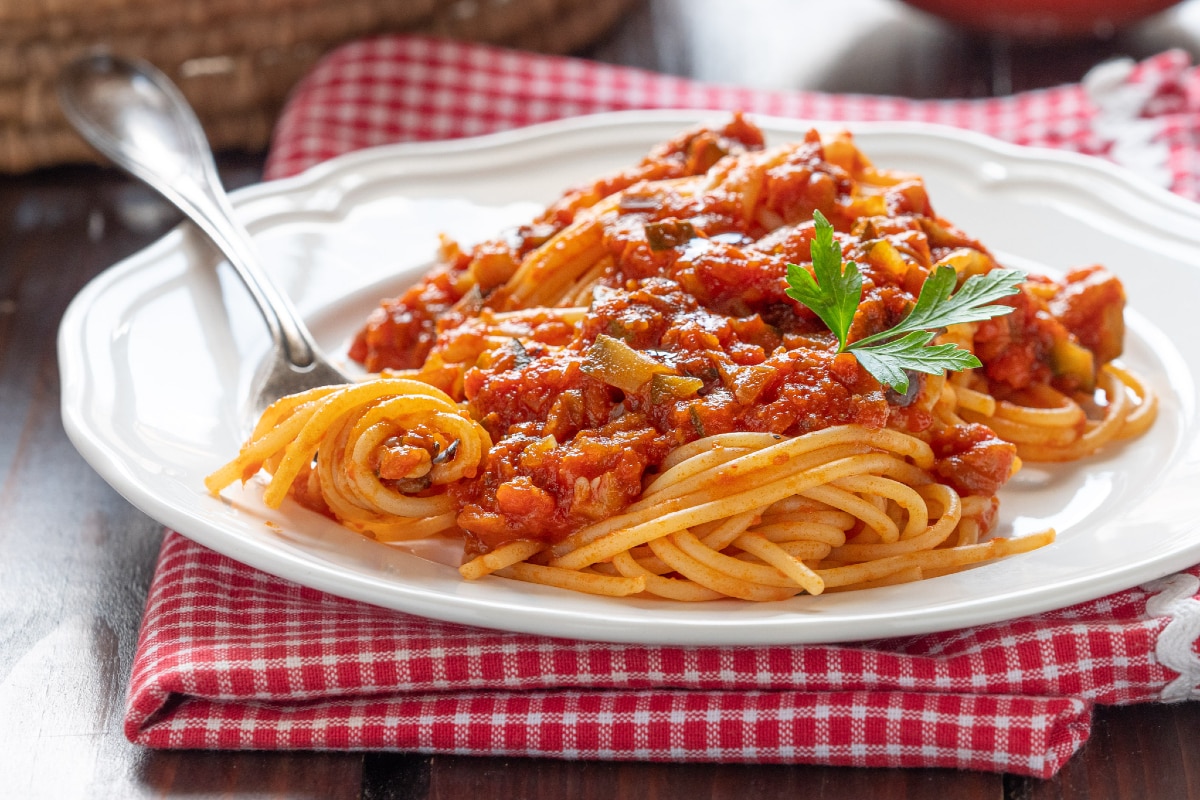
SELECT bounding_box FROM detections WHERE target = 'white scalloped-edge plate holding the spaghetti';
[59,112,1200,644]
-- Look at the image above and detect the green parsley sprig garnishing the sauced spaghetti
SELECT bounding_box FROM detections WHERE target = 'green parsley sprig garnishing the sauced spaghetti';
[787,211,1025,393]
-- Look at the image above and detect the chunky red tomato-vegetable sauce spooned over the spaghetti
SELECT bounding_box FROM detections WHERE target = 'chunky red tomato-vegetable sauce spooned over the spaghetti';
[353,118,1123,551]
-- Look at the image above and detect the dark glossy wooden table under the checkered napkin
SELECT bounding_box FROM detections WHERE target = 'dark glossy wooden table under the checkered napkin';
[0,0,1200,800]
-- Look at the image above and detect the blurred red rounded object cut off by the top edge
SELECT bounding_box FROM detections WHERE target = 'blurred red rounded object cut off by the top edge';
[905,0,1178,38]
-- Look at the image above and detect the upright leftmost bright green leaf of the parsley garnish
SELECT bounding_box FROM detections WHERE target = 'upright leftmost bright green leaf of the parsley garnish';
[786,211,863,353]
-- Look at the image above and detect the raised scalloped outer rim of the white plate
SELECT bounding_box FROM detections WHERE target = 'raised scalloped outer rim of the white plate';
[59,110,1200,644]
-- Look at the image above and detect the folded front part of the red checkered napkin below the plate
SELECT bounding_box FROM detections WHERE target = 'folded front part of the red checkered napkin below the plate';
[125,531,1200,777]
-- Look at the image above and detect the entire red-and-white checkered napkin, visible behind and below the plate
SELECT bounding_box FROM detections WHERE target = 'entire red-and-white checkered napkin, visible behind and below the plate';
[125,37,1200,777]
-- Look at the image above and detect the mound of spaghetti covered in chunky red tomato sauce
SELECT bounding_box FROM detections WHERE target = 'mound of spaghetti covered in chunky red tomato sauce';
[208,116,1156,601]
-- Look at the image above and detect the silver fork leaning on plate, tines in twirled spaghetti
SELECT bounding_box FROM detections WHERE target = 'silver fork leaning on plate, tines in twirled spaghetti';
[58,55,353,420]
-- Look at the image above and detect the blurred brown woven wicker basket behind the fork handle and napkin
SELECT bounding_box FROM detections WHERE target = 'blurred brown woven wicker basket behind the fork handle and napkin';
[0,0,634,173]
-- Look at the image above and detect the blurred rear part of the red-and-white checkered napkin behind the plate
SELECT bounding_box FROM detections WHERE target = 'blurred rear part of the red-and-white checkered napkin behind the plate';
[266,36,1200,199]
